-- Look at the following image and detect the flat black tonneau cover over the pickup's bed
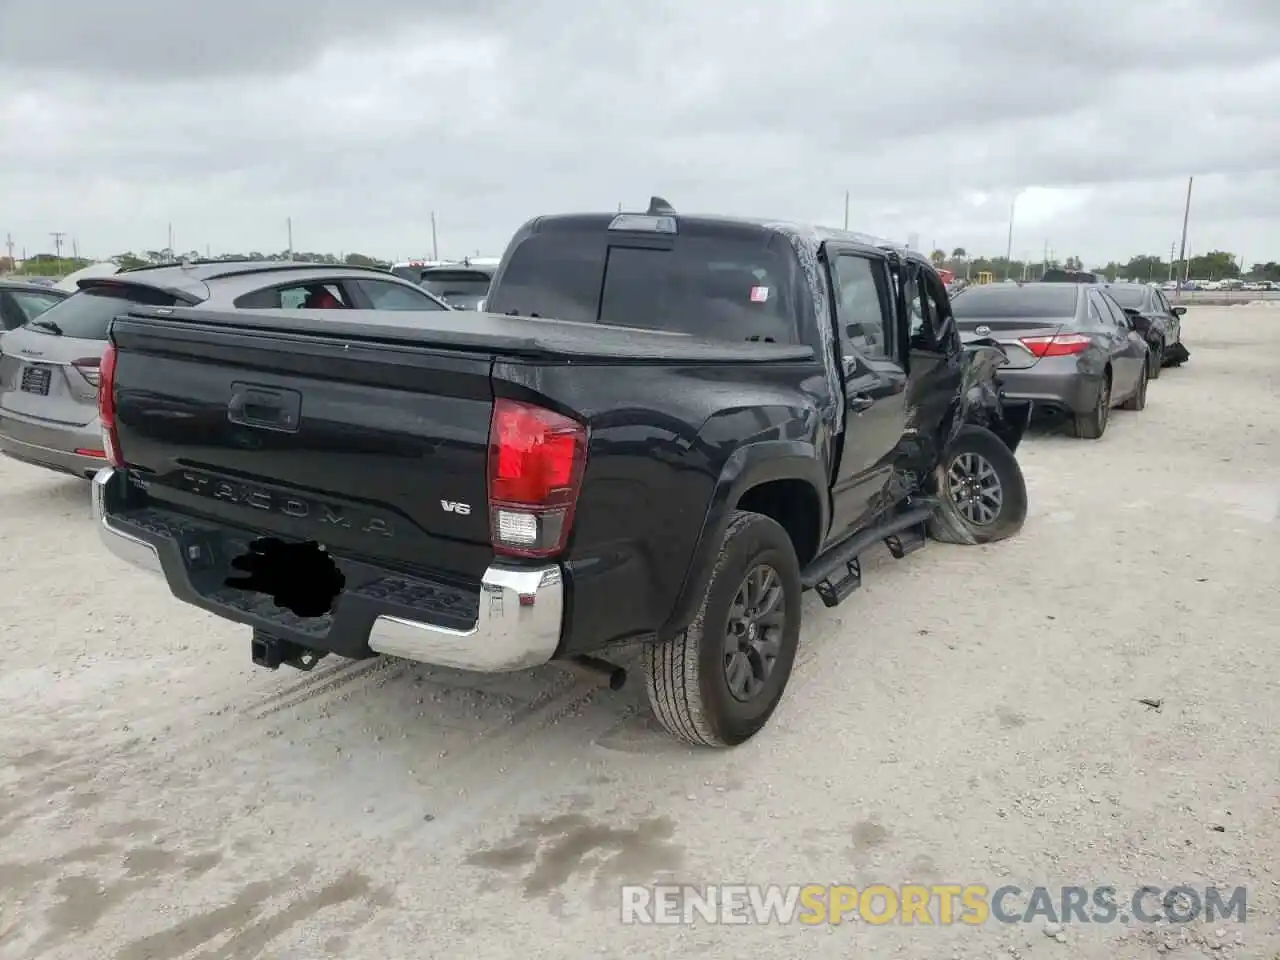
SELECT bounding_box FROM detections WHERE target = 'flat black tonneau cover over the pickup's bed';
[119,307,814,364]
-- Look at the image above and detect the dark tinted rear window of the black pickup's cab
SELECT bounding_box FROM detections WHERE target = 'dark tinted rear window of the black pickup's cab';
[486,232,799,343]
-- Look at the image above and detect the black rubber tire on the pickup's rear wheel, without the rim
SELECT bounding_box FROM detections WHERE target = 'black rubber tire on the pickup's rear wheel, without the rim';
[644,511,801,748]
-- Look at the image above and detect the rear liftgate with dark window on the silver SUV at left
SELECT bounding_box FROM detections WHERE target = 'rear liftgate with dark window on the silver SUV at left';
[0,282,175,426]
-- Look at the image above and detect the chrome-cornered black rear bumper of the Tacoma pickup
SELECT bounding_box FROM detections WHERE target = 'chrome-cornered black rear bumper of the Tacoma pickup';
[92,467,564,673]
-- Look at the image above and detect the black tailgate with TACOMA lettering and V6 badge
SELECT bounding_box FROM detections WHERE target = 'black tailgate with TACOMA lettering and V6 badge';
[113,316,493,579]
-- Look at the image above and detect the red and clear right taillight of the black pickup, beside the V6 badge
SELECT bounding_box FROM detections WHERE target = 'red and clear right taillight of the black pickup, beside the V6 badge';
[489,398,586,557]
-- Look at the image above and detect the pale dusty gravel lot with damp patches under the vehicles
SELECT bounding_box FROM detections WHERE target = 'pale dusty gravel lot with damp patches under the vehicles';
[0,307,1280,960]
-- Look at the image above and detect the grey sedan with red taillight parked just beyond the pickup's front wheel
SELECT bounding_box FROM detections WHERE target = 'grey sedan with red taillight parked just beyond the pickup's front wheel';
[952,283,1151,439]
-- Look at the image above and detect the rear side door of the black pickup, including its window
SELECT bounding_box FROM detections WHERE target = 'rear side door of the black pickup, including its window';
[824,243,908,540]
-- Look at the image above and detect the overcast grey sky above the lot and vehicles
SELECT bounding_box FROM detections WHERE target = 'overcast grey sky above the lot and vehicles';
[0,0,1280,265]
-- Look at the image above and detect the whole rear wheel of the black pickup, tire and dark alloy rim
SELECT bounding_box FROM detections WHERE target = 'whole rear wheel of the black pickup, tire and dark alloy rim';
[645,511,801,748]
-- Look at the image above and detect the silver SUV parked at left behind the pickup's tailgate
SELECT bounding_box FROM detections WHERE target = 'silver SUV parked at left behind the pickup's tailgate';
[0,261,449,477]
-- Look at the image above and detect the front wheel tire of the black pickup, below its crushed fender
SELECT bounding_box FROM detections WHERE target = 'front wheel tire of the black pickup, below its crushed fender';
[928,424,1027,544]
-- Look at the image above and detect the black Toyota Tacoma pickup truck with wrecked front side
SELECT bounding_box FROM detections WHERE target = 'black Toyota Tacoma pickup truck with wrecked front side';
[93,198,1030,746]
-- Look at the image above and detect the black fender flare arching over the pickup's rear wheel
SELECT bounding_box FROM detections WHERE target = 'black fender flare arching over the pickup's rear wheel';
[662,440,831,636]
